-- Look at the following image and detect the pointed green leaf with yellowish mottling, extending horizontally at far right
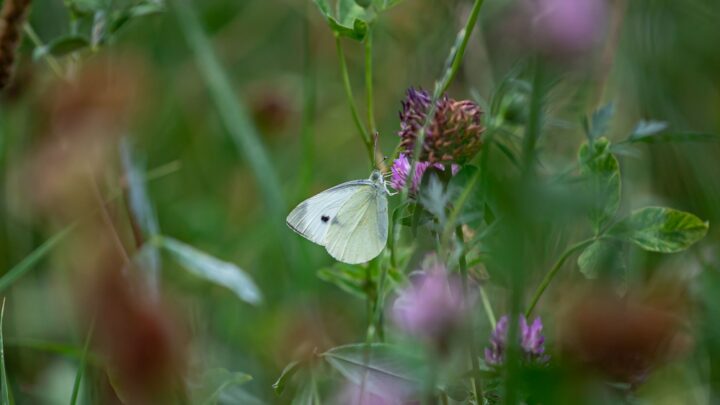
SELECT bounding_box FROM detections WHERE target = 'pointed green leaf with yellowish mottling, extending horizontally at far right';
[609,207,708,253]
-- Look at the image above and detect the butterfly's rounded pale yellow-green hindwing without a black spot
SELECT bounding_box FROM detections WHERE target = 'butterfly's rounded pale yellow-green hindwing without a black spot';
[325,187,388,264]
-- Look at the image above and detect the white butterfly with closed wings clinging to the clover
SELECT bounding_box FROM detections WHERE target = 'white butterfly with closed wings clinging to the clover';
[286,171,393,264]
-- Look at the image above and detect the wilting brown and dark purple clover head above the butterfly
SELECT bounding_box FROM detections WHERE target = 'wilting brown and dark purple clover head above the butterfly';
[398,88,485,165]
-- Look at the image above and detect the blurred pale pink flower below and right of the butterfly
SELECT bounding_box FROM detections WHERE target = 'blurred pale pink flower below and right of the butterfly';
[391,256,464,340]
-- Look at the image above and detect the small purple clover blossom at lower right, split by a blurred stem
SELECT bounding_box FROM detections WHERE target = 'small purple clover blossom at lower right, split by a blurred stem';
[485,315,549,366]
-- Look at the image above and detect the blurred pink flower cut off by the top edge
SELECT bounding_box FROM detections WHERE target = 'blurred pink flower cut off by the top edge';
[526,0,607,54]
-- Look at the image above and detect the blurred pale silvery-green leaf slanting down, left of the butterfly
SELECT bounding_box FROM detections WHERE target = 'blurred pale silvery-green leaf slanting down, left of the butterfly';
[159,236,262,305]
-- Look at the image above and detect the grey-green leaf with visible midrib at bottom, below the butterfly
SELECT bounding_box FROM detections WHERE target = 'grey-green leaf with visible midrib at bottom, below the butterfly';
[321,343,429,395]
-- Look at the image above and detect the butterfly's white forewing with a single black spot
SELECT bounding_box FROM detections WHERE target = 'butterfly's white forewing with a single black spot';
[286,180,373,246]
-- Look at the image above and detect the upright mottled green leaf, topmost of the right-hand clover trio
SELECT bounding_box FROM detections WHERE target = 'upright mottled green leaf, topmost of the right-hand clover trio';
[579,138,622,235]
